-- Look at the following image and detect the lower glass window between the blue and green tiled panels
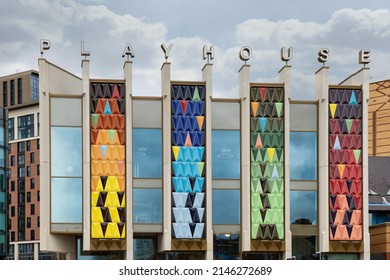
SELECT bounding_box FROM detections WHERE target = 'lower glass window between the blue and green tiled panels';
[213,190,240,225]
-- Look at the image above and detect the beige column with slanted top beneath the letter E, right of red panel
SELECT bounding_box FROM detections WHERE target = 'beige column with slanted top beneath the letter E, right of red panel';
[341,68,370,260]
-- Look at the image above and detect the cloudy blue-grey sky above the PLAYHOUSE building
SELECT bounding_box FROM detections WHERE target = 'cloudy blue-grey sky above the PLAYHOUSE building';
[0,0,390,99]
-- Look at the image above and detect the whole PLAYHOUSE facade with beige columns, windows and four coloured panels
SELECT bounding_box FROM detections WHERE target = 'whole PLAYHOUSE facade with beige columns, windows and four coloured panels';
[32,59,370,260]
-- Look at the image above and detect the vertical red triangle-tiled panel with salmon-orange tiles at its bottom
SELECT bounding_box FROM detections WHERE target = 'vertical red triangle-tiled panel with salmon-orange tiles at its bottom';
[329,88,363,241]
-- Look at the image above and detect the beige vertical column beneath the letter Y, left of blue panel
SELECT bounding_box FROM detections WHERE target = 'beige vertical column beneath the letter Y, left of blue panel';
[158,62,172,252]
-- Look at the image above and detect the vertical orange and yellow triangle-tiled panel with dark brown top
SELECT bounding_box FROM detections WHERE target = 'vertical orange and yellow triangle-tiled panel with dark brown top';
[90,83,126,239]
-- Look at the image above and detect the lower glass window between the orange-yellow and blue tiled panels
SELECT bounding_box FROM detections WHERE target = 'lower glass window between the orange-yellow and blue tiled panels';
[133,189,162,224]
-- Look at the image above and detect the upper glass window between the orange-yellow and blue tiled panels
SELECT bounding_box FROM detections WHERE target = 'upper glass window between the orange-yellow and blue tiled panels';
[133,128,162,178]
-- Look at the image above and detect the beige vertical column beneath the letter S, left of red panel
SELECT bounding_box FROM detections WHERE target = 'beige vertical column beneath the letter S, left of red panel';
[315,67,329,252]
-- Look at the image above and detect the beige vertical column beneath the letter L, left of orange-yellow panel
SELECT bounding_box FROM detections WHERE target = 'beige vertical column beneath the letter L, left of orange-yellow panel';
[81,60,91,251]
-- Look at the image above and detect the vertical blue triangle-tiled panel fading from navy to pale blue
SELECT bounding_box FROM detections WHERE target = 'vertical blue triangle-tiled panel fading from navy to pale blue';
[171,85,206,239]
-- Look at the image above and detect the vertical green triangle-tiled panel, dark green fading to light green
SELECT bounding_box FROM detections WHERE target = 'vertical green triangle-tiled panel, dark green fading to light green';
[250,87,284,240]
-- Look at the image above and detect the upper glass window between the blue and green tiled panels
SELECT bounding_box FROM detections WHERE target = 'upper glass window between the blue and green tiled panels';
[212,130,241,179]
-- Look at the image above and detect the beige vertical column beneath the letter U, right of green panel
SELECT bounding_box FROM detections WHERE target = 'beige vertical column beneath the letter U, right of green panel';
[279,65,292,259]
